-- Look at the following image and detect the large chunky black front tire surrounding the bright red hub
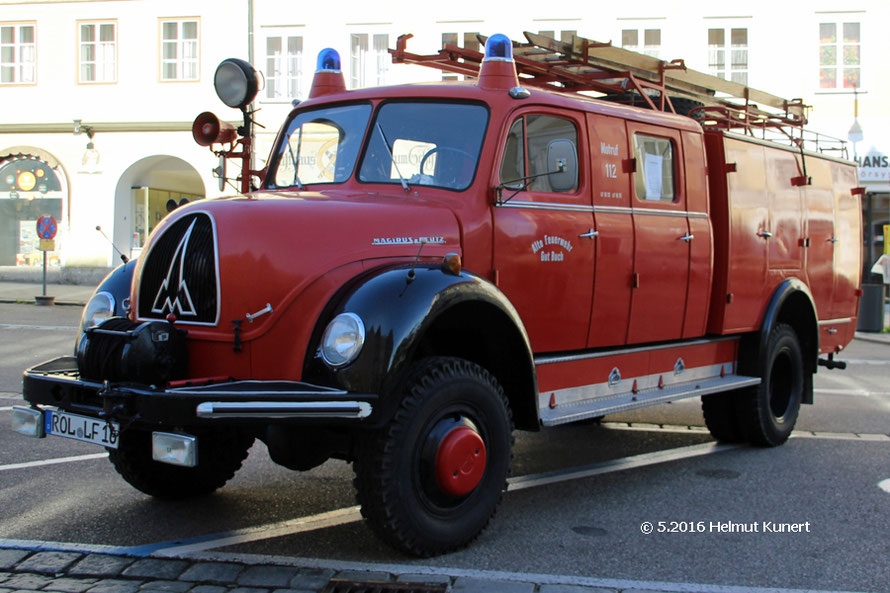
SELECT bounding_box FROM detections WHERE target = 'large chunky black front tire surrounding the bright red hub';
[355,358,513,557]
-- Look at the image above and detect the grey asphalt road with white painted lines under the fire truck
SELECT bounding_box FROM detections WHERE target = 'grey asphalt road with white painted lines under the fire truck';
[0,304,890,592]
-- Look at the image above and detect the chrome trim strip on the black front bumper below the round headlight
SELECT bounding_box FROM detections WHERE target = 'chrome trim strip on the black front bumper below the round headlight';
[195,401,372,419]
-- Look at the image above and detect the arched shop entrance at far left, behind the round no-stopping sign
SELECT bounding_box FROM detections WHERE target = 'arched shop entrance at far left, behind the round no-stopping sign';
[0,146,69,266]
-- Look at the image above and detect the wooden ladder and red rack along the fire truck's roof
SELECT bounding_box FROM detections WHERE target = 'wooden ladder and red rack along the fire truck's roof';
[389,32,845,157]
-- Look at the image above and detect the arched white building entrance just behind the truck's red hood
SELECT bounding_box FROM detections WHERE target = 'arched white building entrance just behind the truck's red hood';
[114,155,206,257]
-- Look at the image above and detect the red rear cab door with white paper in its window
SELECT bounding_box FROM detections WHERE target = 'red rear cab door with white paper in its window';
[627,122,695,344]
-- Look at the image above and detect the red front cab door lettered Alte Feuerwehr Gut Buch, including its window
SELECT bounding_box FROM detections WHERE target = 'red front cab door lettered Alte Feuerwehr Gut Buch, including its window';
[493,109,596,352]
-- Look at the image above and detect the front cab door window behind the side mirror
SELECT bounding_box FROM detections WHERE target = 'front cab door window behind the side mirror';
[500,115,578,193]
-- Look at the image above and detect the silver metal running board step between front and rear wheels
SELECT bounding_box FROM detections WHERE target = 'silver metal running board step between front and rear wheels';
[538,374,760,426]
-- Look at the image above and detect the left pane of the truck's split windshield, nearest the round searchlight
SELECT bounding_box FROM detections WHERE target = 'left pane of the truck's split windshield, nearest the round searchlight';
[271,103,371,188]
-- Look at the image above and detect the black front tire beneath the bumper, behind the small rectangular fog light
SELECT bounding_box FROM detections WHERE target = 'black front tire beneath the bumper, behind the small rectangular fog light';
[108,429,254,499]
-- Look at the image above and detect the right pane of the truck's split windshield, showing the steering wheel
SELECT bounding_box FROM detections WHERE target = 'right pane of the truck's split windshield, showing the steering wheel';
[359,101,488,190]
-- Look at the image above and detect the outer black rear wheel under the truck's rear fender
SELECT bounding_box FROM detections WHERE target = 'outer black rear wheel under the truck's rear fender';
[738,324,806,447]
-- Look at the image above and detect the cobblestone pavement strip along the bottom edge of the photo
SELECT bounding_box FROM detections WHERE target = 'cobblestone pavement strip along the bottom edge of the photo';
[0,540,872,593]
